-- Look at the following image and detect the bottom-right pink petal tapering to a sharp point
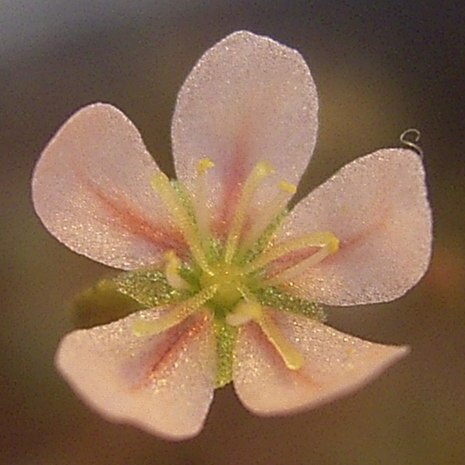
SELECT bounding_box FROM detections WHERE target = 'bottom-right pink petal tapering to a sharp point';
[234,312,408,415]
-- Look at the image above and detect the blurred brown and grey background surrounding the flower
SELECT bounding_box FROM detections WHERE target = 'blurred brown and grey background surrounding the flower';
[0,0,465,465]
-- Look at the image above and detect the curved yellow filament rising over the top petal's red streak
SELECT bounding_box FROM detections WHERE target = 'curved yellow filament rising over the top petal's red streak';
[224,162,273,263]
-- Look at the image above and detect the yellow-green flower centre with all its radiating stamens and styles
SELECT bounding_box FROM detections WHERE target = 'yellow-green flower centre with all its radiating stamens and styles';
[134,159,339,376]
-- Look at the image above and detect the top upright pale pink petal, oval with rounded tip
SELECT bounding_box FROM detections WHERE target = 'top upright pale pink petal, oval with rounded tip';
[172,31,318,232]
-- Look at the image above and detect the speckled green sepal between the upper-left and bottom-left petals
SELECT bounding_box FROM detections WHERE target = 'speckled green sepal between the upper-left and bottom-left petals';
[113,270,186,308]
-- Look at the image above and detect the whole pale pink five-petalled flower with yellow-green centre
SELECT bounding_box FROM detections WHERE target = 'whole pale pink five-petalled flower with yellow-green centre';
[32,32,431,439]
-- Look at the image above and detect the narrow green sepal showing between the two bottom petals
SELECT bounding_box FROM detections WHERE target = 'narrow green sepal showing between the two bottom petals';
[214,318,237,388]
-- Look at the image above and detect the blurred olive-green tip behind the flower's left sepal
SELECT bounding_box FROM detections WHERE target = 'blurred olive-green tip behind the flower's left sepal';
[69,279,141,329]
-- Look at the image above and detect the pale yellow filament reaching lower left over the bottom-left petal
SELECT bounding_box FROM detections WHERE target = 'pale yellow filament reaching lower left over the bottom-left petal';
[132,285,218,336]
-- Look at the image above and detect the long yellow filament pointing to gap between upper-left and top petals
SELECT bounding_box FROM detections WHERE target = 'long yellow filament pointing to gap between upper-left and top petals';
[152,173,211,273]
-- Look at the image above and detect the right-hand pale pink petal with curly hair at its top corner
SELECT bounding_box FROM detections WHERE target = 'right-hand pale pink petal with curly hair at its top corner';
[274,149,432,305]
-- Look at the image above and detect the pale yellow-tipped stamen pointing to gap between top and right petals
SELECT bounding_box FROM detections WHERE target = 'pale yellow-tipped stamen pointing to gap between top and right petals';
[243,181,297,249]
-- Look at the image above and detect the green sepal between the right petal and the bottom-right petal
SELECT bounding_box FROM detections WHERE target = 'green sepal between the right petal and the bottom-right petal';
[254,287,326,321]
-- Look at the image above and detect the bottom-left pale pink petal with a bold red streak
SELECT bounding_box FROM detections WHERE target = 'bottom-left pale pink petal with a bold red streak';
[56,310,215,440]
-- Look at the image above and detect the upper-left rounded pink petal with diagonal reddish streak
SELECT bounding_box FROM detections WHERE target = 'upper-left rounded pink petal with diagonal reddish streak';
[32,103,183,269]
